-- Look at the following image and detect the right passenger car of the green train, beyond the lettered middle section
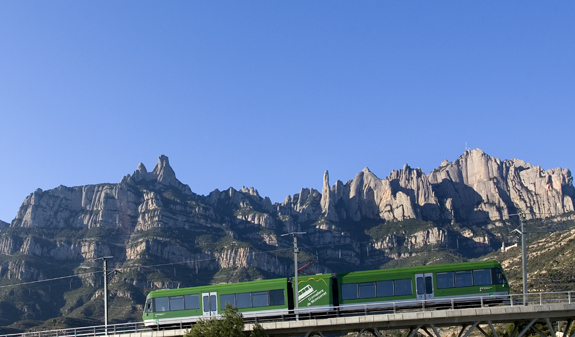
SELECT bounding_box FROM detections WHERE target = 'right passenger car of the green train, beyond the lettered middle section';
[337,261,509,311]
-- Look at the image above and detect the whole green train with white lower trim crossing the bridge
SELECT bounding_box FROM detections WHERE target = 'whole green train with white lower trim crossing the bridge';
[142,261,509,326]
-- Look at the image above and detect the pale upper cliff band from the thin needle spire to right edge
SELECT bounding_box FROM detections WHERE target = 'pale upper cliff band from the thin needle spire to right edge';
[322,149,575,223]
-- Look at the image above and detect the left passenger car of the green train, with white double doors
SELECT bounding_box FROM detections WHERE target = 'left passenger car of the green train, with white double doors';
[143,278,293,326]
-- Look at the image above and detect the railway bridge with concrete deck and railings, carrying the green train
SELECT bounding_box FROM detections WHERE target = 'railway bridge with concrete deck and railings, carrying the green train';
[4,292,575,337]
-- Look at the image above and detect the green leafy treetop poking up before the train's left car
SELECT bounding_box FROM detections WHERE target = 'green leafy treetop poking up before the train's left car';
[184,303,267,337]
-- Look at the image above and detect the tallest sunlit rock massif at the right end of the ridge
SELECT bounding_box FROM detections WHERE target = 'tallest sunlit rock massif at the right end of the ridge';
[428,149,574,222]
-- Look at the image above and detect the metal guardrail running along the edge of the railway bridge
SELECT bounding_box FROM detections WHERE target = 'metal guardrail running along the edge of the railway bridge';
[0,291,575,337]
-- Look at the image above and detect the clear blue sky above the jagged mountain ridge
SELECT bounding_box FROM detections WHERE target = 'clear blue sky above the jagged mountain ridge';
[0,0,575,222]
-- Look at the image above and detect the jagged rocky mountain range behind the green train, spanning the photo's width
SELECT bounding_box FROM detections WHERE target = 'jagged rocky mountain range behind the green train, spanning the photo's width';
[0,150,575,328]
